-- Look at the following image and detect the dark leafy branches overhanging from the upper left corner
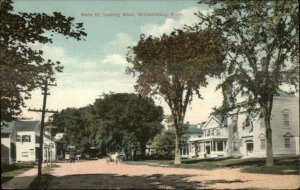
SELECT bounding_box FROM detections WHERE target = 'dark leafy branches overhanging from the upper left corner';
[0,0,86,125]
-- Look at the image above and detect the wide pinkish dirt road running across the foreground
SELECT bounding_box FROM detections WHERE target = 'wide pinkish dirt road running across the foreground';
[45,160,300,189]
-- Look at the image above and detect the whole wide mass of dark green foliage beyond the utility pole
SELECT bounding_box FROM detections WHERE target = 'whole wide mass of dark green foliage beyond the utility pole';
[54,93,163,159]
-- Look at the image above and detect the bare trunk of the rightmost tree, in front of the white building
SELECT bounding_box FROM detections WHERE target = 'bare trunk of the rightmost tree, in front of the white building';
[261,104,274,166]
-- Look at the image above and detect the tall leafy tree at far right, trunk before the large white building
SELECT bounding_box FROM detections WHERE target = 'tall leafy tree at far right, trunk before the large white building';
[198,0,299,166]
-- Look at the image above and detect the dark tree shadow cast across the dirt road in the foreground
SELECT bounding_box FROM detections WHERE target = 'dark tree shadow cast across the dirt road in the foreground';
[48,174,248,189]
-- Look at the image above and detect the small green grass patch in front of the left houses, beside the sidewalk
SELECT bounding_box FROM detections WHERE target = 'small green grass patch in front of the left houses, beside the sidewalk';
[1,163,34,184]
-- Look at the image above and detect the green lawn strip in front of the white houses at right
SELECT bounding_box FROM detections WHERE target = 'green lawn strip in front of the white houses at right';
[127,156,300,174]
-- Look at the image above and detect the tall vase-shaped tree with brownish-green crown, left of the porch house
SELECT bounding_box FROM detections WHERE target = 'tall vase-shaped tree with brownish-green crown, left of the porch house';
[127,30,224,164]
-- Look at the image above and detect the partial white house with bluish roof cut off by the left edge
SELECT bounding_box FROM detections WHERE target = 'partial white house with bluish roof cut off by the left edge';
[1,122,17,164]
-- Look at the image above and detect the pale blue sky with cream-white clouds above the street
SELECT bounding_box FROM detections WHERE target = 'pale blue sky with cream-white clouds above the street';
[13,0,223,124]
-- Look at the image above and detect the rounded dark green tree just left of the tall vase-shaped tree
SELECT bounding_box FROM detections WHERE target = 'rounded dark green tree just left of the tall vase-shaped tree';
[94,93,163,157]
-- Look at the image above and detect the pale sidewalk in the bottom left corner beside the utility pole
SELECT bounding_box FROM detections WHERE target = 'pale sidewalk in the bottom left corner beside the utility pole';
[1,167,37,189]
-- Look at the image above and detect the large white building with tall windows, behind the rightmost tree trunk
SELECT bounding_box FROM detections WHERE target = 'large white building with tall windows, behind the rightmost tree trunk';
[228,92,299,157]
